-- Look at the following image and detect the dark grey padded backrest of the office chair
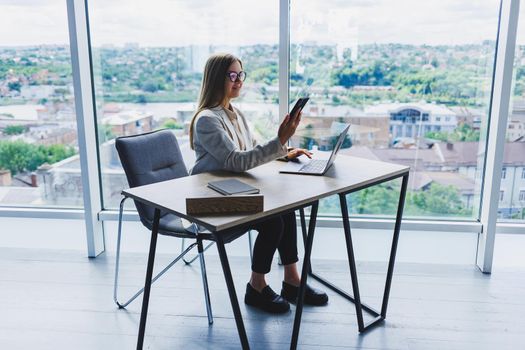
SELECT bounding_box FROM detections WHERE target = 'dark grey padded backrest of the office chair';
[115,129,188,228]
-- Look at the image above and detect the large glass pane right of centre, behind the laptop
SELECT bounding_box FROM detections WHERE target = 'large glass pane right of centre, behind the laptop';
[290,0,499,219]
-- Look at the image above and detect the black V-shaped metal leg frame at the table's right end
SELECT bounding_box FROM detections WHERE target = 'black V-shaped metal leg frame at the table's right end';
[301,174,408,332]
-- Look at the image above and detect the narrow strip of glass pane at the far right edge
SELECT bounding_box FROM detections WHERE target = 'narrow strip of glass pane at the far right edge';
[498,4,525,222]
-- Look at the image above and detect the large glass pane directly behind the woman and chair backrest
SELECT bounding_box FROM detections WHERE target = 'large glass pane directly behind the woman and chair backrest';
[89,0,279,208]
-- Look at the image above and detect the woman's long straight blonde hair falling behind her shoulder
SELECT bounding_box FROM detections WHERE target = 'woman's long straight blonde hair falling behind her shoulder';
[190,53,242,149]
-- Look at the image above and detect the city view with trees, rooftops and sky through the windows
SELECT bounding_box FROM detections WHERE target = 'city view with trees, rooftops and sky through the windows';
[0,1,525,219]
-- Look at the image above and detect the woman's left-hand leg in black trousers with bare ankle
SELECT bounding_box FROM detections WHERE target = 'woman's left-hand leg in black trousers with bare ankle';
[250,216,283,292]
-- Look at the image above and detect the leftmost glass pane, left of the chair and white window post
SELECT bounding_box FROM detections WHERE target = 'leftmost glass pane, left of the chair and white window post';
[0,1,83,207]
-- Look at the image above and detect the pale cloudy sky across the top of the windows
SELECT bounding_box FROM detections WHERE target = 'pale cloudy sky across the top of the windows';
[0,0,525,47]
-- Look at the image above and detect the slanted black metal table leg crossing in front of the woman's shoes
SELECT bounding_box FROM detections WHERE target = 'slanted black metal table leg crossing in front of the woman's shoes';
[290,201,319,350]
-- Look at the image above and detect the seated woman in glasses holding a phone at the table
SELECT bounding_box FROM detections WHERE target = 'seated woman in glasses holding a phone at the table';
[190,54,328,313]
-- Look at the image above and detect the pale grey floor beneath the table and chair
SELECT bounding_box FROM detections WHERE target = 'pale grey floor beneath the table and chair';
[0,248,525,349]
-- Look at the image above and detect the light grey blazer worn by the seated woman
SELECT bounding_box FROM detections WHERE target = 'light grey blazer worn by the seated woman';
[190,107,287,174]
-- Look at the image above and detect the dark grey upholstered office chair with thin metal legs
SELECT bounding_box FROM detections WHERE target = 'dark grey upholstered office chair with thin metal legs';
[113,130,252,324]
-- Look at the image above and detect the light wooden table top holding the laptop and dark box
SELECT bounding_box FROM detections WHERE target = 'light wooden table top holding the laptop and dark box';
[122,155,409,231]
